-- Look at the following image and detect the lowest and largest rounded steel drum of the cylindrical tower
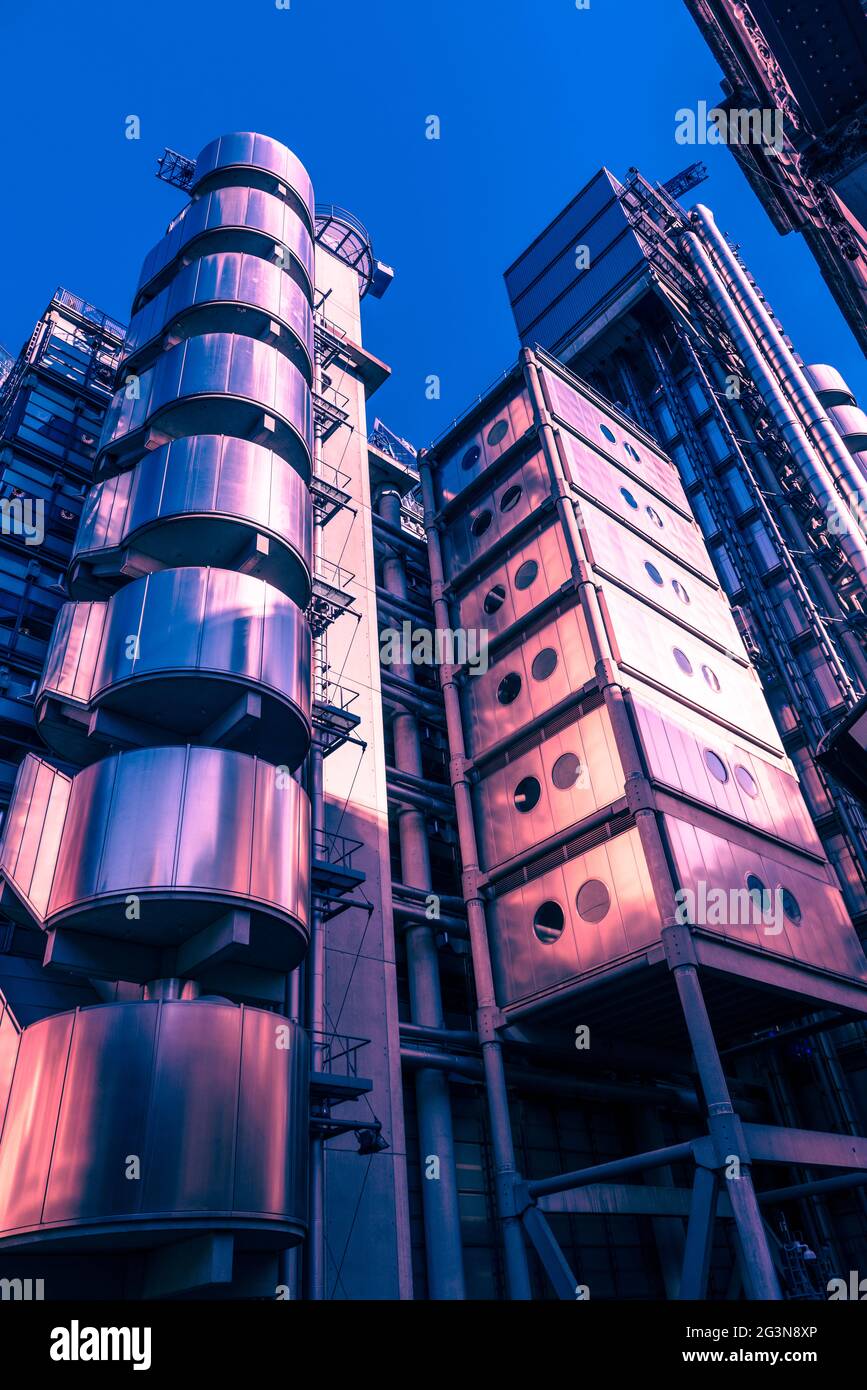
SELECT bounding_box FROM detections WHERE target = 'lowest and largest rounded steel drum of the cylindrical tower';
[0,999,308,1250]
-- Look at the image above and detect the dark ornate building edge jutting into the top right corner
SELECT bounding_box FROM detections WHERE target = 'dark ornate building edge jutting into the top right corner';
[686,0,867,350]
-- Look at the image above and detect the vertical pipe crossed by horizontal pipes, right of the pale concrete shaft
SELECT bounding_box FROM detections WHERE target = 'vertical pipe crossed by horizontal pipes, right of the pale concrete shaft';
[377,489,465,1300]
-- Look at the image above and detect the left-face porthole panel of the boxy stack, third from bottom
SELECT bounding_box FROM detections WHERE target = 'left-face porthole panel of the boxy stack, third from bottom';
[463,606,595,758]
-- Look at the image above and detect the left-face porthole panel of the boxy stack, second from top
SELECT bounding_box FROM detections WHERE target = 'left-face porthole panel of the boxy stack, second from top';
[443,453,553,578]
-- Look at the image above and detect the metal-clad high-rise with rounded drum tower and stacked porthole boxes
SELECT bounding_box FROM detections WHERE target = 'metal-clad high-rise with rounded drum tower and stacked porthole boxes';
[0,135,867,1300]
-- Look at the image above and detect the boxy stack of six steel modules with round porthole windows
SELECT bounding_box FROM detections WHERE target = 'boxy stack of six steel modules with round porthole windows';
[422,349,867,1297]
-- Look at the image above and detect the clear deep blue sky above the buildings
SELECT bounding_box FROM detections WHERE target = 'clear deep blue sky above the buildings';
[0,0,867,443]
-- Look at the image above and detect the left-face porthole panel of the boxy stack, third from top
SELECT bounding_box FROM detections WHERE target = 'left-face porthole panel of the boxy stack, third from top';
[457,524,571,639]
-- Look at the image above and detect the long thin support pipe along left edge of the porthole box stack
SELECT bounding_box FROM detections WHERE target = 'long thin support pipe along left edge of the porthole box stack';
[418,457,531,1300]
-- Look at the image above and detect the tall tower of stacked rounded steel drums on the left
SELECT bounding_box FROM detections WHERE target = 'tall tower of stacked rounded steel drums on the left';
[0,133,314,1294]
